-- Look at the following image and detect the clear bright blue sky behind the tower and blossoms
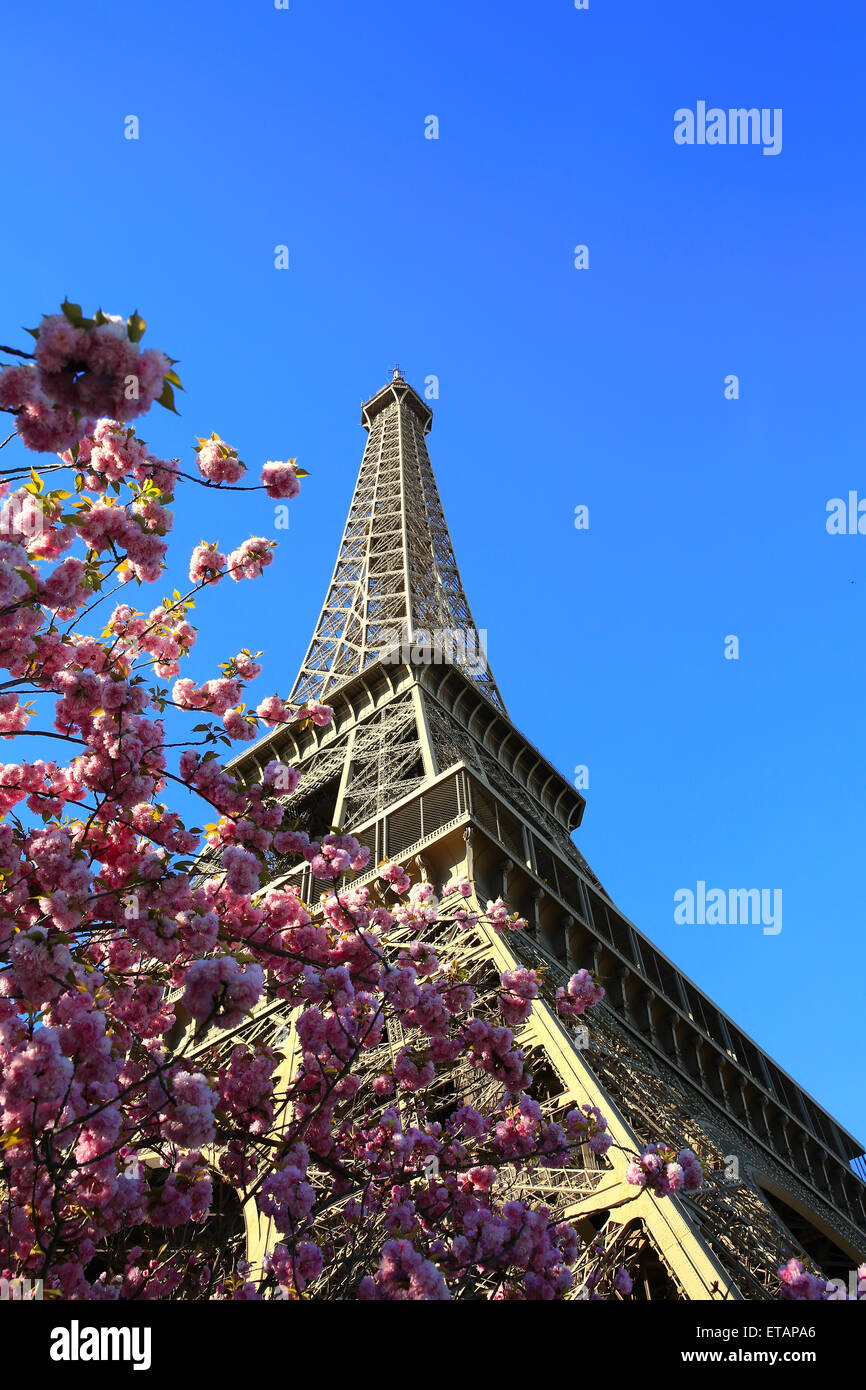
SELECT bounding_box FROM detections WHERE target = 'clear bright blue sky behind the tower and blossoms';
[0,0,866,1138]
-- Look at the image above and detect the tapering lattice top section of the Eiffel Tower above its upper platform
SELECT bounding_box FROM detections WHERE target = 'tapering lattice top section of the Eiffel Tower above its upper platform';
[291,375,505,713]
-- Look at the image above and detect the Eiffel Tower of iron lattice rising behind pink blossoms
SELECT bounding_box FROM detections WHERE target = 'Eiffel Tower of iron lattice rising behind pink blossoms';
[186,368,866,1300]
